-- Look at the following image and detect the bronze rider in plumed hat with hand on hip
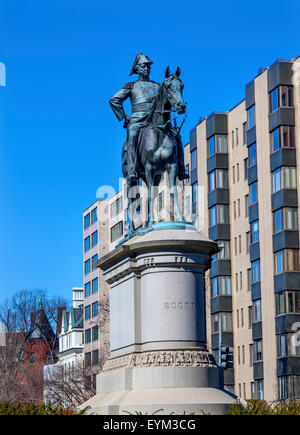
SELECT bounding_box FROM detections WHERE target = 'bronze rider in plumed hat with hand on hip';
[109,53,189,181]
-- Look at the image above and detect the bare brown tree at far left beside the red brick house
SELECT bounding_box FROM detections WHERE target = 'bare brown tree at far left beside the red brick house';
[0,289,67,400]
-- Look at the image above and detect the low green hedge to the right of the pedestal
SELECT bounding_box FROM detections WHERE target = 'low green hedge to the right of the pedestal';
[228,399,300,415]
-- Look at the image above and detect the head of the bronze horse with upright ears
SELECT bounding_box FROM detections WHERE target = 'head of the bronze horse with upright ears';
[162,66,187,114]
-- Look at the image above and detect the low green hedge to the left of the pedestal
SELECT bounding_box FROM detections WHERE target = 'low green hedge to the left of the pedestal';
[0,401,86,415]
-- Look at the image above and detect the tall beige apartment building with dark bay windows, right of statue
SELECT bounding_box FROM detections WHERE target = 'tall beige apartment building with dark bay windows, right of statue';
[185,58,300,401]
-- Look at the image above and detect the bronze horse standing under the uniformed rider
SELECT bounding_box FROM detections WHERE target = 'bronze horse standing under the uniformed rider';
[122,67,186,236]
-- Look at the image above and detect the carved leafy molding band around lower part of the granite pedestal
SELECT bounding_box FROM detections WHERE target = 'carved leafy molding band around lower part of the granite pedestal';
[103,347,217,372]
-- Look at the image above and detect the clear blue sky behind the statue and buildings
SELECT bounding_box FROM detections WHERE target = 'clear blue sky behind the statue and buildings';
[0,0,300,302]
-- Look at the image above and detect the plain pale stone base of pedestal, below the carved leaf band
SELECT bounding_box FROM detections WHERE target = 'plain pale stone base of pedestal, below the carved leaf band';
[82,367,235,415]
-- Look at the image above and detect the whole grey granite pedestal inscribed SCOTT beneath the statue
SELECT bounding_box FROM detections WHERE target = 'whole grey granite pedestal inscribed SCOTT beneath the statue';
[83,225,235,415]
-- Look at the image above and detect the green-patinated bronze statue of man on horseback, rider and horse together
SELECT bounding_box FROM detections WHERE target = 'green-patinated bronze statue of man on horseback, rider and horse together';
[110,53,189,237]
